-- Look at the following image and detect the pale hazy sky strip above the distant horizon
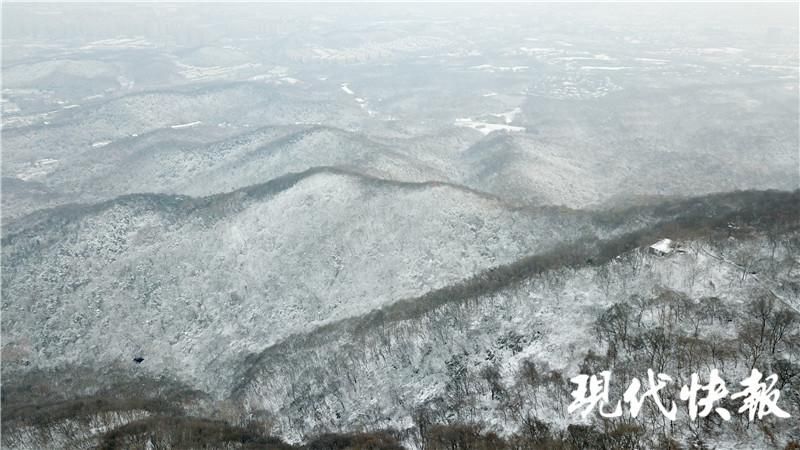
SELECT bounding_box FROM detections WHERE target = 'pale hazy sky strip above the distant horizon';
[3,1,800,35]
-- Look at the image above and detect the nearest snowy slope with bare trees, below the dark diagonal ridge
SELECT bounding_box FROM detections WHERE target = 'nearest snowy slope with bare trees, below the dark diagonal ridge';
[235,193,800,446]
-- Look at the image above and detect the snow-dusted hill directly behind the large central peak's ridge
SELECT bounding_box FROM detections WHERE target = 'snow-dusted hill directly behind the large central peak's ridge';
[31,125,448,201]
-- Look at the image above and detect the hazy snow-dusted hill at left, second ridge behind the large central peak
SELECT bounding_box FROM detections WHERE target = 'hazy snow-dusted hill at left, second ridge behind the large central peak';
[3,83,365,174]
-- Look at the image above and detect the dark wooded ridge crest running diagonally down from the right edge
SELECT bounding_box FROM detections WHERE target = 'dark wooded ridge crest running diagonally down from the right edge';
[231,190,800,399]
